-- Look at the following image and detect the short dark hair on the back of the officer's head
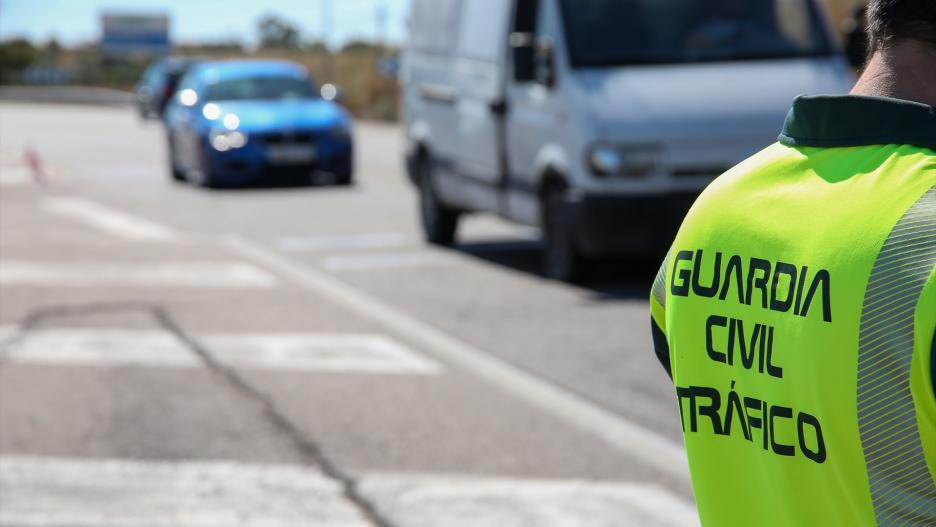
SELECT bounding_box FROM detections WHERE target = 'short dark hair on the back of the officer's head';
[867,0,936,53]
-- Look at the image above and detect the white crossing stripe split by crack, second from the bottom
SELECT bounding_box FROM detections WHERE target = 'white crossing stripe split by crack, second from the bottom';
[0,327,442,375]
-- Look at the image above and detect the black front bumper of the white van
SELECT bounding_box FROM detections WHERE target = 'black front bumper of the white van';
[567,192,699,256]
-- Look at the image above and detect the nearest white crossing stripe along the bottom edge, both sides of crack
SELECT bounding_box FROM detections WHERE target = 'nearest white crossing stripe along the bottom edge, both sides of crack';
[0,456,699,527]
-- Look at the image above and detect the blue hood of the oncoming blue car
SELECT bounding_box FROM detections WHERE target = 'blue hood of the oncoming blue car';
[207,100,348,132]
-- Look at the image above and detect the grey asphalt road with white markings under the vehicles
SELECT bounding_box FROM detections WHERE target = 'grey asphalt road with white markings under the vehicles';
[0,103,697,527]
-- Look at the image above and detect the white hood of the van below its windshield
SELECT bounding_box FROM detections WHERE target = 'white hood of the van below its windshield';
[580,58,851,141]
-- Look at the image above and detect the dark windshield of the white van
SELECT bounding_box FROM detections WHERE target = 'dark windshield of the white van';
[561,0,831,67]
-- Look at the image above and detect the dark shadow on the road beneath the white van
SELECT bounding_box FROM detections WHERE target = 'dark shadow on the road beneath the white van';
[452,240,665,302]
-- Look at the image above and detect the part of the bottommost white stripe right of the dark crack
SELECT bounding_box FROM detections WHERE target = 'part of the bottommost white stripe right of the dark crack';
[358,474,699,527]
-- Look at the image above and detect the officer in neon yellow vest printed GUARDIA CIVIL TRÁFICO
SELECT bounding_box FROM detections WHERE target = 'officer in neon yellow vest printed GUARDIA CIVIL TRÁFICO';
[650,0,936,527]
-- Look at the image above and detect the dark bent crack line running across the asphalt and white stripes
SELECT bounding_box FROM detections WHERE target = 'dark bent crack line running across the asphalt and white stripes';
[0,302,394,527]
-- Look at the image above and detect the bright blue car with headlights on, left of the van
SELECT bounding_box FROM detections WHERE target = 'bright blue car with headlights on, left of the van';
[165,60,354,188]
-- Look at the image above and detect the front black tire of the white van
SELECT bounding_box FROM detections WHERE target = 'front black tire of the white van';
[542,184,586,282]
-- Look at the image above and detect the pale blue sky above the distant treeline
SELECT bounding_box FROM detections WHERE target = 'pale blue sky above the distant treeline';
[0,0,410,45]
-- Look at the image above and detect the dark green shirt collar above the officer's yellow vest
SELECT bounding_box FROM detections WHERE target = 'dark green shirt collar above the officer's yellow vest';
[779,95,936,150]
